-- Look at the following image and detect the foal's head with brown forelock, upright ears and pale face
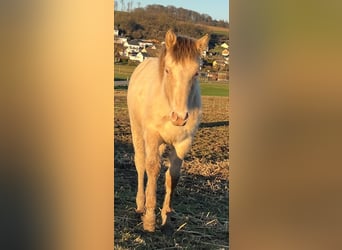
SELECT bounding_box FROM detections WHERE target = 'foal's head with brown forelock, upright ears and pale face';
[160,30,209,126]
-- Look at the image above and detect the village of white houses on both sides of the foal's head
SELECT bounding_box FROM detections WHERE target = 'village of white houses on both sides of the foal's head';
[114,29,229,82]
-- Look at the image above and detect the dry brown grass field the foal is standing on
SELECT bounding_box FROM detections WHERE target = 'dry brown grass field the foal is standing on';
[114,90,229,250]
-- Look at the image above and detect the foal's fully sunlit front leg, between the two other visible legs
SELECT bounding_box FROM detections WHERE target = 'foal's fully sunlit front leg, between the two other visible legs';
[142,133,161,232]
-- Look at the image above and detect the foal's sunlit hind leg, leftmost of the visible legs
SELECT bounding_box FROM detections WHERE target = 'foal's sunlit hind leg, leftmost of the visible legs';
[132,126,145,214]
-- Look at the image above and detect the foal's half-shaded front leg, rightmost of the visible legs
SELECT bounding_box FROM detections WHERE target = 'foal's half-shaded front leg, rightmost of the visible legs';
[161,140,191,233]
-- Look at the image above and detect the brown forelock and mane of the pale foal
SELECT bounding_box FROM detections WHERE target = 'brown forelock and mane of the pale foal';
[159,36,199,77]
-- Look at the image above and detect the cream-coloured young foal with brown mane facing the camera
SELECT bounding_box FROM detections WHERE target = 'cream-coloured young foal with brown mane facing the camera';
[127,30,208,232]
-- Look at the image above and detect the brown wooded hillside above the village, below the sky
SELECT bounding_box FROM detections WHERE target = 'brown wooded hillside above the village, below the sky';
[114,5,229,46]
